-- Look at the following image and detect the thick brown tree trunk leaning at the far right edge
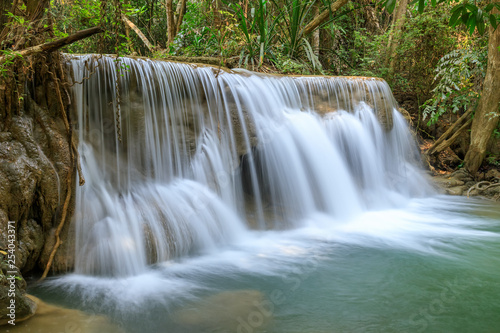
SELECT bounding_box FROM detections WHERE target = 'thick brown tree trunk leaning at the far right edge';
[464,16,500,174]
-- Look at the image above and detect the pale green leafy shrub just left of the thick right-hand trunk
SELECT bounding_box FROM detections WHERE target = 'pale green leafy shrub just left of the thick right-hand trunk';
[423,47,487,125]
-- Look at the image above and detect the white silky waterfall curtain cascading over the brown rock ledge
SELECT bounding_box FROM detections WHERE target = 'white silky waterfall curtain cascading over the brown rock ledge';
[68,55,431,276]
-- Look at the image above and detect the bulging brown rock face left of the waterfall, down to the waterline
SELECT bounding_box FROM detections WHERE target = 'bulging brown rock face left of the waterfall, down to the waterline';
[0,89,74,321]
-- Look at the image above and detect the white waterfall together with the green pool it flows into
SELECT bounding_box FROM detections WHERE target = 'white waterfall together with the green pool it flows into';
[29,55,500,333]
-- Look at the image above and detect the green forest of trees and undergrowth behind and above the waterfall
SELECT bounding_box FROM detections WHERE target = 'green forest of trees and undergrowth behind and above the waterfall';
[0,0,500,174]
